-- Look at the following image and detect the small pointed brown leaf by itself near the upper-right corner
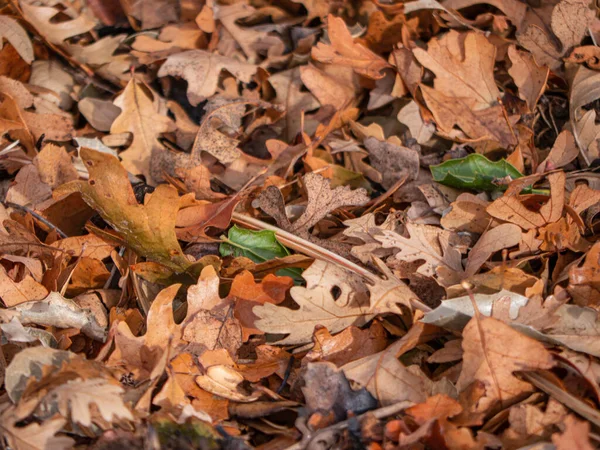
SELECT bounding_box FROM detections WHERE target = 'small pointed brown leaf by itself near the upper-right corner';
[508,45,550,111]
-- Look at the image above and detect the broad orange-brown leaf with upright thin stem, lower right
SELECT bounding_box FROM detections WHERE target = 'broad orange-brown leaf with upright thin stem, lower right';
[456,312,554,413]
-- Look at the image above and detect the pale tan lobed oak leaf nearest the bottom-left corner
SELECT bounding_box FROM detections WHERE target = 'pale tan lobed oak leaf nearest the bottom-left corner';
[47,378,133,427]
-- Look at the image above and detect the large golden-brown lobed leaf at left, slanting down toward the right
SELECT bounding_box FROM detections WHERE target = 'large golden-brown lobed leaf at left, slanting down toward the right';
[54,148,191,272]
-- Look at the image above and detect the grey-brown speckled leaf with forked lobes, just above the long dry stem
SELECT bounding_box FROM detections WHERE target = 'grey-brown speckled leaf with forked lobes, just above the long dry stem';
[255,172,369,253]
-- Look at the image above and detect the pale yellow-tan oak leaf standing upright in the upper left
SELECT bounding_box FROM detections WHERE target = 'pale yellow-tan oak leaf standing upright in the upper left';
[110,78,174,184]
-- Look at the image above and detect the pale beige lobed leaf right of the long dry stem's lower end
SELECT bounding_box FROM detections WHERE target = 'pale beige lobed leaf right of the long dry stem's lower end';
[373,223,464,285]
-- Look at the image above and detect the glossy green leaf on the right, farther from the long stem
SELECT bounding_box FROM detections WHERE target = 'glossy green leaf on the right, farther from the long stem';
[430,153,523,191]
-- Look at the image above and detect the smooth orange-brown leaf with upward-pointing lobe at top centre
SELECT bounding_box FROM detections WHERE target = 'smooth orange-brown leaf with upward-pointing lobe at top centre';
[311,15,391,80]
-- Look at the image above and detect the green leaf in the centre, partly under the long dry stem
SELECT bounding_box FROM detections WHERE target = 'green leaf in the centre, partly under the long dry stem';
[219,225,303,283]
